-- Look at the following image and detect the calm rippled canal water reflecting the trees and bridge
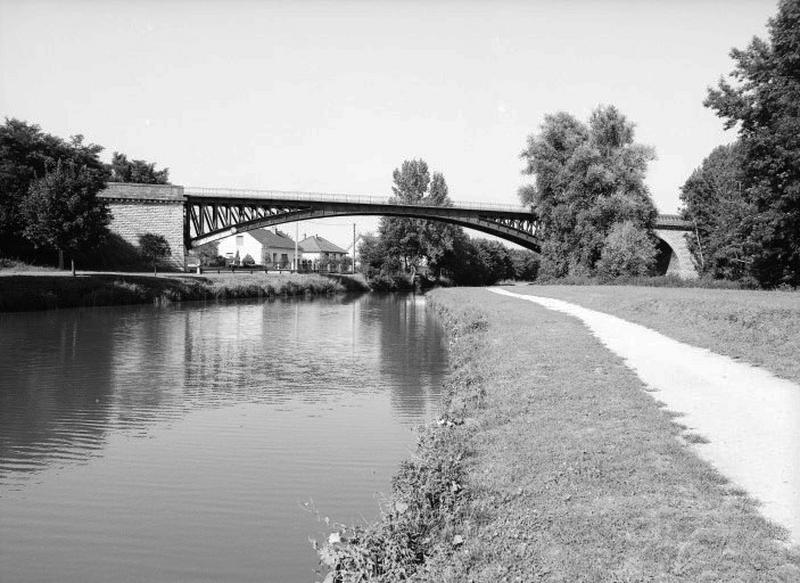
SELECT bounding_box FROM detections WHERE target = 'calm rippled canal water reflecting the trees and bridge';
[0,294,447,583]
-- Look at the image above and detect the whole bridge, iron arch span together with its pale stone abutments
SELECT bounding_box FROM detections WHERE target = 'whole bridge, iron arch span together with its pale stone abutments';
[98,182,697,278]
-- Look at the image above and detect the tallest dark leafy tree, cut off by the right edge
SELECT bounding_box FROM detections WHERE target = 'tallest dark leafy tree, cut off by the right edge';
[705,0,800,287]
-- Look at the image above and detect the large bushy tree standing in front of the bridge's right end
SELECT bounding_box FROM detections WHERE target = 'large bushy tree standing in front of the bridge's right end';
[519,106,657,277]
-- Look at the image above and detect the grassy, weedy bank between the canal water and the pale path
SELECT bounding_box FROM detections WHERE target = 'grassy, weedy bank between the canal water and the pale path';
[321,287,800,582]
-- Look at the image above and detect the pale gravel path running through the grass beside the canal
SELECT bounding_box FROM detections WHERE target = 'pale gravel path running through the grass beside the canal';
[491,288,800,543]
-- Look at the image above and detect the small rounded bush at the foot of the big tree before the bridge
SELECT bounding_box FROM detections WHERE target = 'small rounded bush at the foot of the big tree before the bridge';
[597,221,656,279]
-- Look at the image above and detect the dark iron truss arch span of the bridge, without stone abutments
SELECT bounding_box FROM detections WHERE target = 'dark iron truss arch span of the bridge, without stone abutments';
[184,187,539,251]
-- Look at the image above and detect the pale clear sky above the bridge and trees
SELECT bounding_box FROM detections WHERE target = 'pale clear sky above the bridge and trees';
[0,0,777,246]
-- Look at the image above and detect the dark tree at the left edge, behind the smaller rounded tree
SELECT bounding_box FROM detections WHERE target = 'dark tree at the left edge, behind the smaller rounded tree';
[0,118,108,255]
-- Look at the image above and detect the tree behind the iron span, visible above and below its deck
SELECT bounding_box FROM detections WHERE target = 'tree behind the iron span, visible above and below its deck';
[378,160,461,273]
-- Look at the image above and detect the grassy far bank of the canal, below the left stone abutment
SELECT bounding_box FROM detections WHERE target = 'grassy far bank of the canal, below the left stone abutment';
[0,273,367,311]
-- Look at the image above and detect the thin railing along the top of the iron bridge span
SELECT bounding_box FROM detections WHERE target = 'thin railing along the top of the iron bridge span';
[184,186,530,213]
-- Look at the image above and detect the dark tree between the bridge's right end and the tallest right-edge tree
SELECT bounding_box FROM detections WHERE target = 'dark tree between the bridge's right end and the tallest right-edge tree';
[680,143,752,279]
